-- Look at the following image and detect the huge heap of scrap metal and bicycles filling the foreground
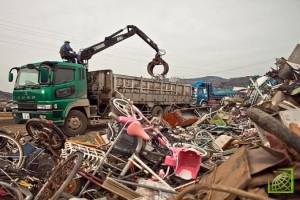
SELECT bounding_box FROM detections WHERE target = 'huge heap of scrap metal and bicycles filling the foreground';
[0,58,300,200]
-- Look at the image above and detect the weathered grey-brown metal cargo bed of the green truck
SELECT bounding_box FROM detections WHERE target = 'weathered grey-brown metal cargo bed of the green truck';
[88,70,192,107]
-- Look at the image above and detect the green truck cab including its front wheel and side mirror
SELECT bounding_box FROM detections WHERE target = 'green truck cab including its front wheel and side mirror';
[9,61,89,135]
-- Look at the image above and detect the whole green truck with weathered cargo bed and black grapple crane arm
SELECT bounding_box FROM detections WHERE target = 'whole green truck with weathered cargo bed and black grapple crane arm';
[9,26,192,136]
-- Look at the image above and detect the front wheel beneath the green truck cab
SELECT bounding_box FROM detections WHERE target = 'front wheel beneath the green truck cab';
[63,110,88,137]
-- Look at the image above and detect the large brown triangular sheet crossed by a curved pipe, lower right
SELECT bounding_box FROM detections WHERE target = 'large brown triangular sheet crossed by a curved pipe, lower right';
[200,147,251,200]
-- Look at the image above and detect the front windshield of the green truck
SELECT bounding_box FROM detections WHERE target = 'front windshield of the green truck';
[15,68,39,88]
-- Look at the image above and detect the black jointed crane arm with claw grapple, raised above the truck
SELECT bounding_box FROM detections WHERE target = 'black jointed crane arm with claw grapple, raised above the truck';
[78,25,169,76]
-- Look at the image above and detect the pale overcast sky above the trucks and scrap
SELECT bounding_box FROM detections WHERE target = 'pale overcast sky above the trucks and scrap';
[0,0,300,91]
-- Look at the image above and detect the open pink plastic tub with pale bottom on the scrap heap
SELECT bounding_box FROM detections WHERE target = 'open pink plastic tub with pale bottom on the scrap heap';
[175,148,201,180]
